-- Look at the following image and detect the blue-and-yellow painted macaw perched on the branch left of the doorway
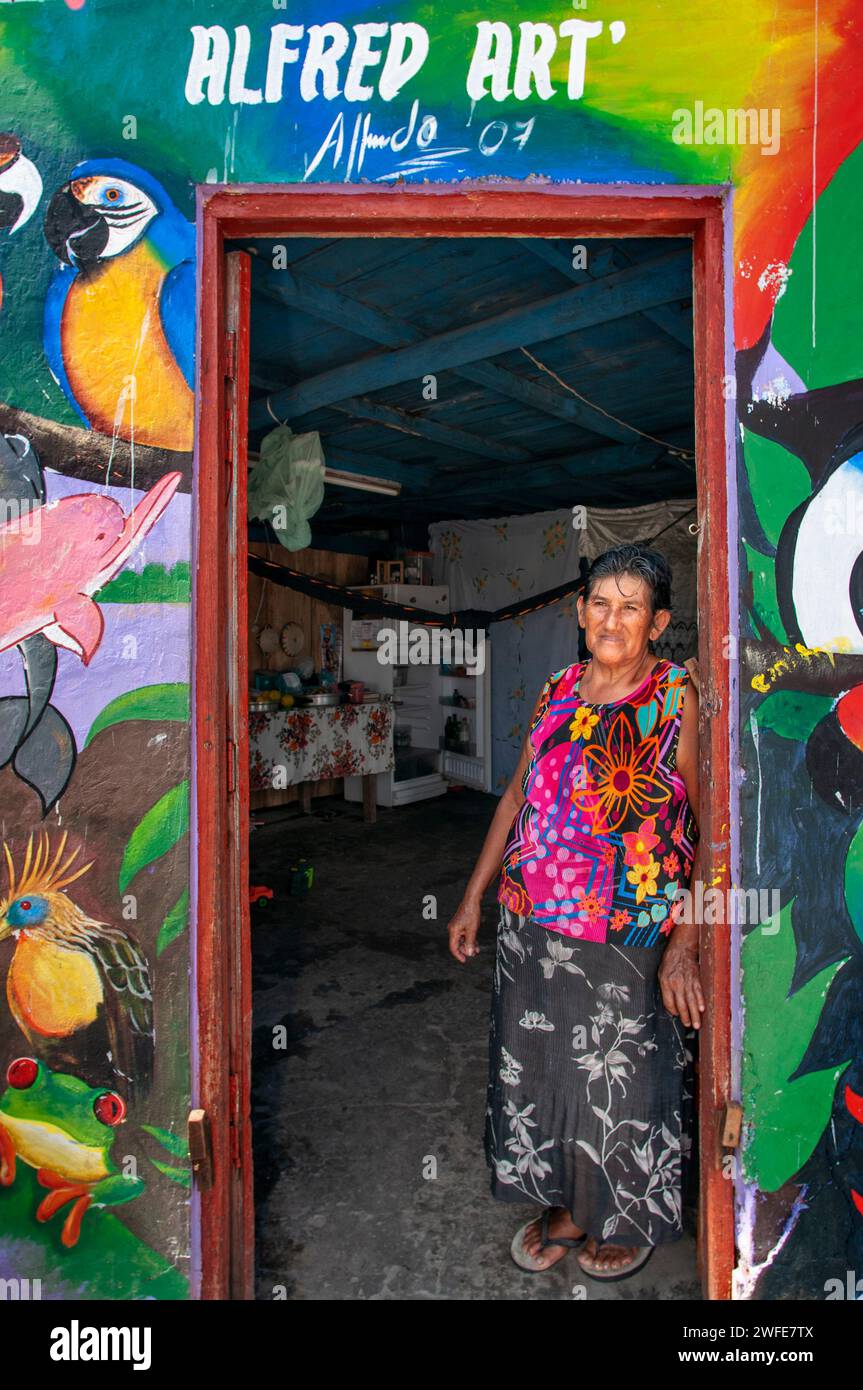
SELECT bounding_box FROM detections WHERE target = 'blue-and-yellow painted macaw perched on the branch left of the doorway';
[44,160,195,450]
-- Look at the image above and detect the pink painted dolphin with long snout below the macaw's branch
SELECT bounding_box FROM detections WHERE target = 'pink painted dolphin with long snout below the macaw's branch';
[0,473,182,666]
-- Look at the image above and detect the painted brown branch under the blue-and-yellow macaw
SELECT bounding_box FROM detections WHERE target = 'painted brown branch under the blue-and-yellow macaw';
[0,403,192,492]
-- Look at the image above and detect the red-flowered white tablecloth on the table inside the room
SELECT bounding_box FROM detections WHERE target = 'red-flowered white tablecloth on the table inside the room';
[249,702,395,791]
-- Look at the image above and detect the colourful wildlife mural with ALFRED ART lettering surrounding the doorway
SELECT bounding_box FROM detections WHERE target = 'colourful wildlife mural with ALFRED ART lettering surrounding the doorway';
[0,0,863,1298]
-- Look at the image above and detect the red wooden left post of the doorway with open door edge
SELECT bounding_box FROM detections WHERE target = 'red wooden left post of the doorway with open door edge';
[193,245,254,1298]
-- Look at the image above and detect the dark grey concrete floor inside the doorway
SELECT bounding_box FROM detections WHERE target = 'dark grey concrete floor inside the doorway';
[252,792,700,1301]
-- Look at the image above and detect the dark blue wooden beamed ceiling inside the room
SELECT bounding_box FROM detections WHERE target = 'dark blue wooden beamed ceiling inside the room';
[236,236,695,545]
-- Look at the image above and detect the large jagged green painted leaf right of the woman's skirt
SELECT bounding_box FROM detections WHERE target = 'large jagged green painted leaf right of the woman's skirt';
[742,904,850,1193]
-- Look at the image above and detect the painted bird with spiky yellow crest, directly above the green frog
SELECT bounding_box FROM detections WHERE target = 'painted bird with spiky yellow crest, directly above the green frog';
[0,833,154,1091]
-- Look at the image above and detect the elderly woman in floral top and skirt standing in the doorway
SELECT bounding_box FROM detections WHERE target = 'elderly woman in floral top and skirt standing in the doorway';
[449,545,705,1280]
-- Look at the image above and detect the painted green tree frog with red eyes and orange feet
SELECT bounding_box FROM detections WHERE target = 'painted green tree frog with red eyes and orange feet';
[0,1056,145,1250]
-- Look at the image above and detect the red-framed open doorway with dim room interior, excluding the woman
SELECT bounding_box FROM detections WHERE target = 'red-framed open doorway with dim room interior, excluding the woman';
[196,189,732,1298]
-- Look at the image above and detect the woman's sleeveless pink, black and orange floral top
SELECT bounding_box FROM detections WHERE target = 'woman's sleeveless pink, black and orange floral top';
[498,660,699,947]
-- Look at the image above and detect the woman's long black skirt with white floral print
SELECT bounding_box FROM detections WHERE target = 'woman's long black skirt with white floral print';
[485,906,695,1245]
